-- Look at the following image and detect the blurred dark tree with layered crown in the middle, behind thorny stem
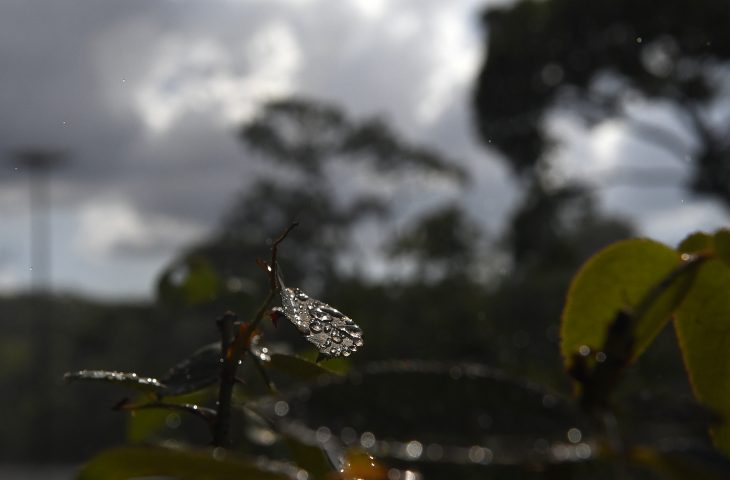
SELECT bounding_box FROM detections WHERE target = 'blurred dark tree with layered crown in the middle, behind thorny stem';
[160,99,466,328]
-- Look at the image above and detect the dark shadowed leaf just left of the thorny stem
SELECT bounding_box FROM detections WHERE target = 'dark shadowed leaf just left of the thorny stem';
[162,343,221,395]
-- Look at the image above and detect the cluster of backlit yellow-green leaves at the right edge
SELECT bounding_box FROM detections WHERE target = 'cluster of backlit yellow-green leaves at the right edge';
[562,230,730,454]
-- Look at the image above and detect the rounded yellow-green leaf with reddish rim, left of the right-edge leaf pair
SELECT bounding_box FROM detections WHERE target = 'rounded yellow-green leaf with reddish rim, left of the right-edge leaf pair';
[561,239,687,368]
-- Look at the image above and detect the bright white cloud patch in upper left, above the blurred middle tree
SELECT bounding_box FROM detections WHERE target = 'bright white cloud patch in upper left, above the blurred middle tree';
[135,21,302,133]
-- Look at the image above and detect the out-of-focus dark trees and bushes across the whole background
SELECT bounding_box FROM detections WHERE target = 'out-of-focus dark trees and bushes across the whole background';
[0,0,730,474]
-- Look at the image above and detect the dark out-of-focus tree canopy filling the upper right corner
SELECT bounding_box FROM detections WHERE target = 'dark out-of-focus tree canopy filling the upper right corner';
[475,0,730,207]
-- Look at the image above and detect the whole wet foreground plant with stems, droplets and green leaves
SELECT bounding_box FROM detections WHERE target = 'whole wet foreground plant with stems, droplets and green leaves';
[66,225,730,480]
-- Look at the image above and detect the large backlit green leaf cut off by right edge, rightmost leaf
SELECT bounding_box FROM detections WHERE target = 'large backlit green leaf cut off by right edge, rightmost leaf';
[675,259,730,454]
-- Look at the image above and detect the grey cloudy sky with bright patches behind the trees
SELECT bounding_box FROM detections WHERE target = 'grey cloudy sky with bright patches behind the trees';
[0,0,728,298]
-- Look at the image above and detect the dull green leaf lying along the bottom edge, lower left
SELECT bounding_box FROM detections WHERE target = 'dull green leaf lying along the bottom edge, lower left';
[76,447,288,480]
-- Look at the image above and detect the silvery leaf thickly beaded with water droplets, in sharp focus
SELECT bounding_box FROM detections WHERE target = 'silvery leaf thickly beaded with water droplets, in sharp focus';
[281,287,363,357]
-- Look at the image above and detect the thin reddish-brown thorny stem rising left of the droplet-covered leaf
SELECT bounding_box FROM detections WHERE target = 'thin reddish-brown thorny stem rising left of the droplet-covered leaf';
[213,222,298,447]
